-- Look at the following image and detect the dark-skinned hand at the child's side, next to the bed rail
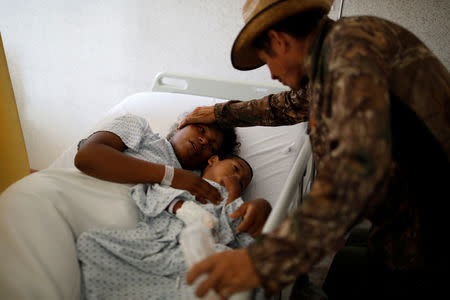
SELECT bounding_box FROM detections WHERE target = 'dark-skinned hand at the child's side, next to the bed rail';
[230,199,272,237]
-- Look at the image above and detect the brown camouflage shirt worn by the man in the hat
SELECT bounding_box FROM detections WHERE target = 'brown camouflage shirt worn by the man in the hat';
[215,17,450,292]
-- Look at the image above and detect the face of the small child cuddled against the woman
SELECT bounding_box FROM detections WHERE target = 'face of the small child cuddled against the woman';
[203,155,252,192]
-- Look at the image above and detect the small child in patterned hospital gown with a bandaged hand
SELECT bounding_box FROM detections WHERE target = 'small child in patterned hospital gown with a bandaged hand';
[77,156,268,299]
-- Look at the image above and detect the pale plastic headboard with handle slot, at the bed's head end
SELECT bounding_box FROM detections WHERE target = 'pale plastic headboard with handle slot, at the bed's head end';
[152,72,288,100]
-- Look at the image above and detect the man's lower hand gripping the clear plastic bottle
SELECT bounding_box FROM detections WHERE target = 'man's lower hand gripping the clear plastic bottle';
[186,249,261,299]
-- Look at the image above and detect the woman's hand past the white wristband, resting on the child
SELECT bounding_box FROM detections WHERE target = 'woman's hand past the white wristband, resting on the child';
[171,168,223,204]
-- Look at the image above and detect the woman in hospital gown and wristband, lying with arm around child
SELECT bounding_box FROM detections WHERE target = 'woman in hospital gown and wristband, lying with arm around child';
[75,114,270,229]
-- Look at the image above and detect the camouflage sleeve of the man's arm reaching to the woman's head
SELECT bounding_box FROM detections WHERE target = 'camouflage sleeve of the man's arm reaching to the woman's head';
[214,87,309,127]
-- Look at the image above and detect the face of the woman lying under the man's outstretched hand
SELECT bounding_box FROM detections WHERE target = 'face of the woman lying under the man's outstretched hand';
[170,124,223,169]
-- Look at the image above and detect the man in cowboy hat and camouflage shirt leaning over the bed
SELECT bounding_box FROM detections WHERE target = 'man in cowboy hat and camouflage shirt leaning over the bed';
[181,0,450,299]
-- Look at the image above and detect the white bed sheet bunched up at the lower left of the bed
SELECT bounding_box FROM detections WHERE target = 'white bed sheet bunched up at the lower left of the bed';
[0,168,137,299]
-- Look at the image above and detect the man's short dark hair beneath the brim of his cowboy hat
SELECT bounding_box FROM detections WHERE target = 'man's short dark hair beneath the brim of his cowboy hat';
[253,10,325,55]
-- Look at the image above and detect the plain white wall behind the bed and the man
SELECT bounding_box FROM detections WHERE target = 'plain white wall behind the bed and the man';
[0,0,450,169]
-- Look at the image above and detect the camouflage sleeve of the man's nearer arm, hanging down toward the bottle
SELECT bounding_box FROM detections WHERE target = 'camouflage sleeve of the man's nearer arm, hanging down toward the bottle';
[249,22,391,292]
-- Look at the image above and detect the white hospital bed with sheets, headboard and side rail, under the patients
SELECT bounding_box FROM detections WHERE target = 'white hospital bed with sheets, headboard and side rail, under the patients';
[0,73,314,299]
